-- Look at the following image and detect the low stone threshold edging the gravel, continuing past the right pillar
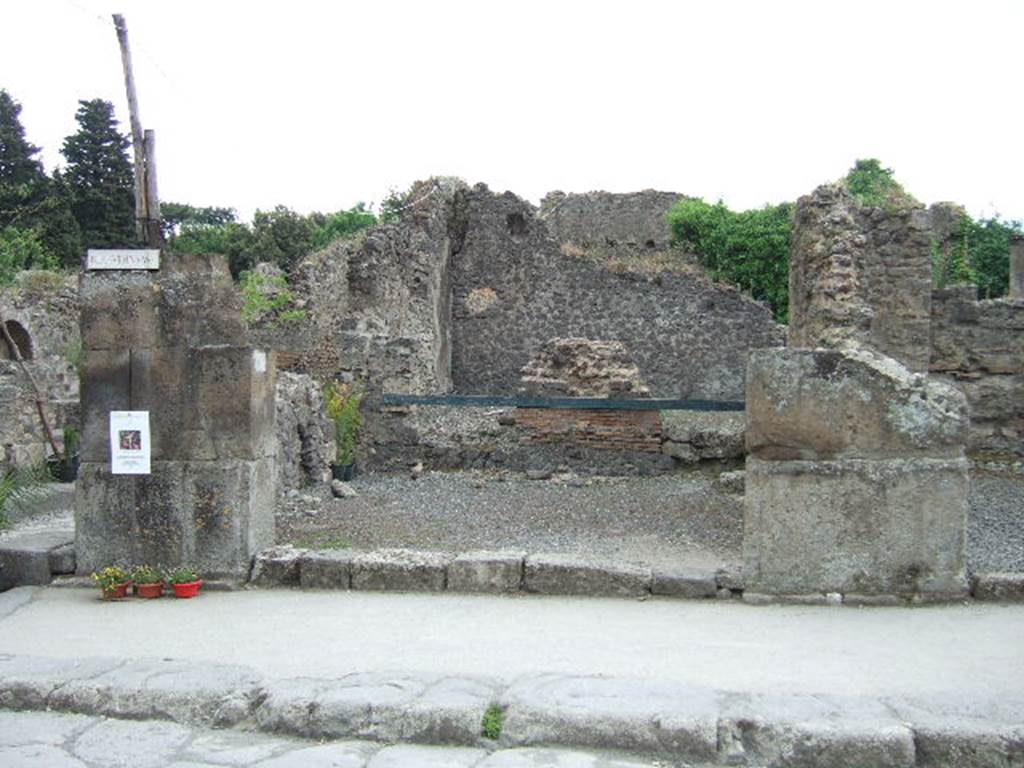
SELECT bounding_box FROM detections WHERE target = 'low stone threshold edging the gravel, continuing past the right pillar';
[249,545,1024,606]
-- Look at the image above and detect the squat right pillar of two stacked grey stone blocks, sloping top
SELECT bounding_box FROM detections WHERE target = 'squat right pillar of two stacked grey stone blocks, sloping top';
[743,348,968,599]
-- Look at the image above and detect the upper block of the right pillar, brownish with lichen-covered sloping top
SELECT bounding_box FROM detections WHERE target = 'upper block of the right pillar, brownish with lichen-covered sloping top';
[746,349,968,460]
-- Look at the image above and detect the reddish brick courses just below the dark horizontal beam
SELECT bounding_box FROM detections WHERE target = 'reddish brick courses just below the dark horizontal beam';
[515,408,662,454]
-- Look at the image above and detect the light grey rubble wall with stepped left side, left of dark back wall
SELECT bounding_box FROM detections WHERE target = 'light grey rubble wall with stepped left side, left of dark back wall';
[254,181,458,393]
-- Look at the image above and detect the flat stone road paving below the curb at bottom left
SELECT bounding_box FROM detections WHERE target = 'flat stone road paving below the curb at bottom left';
[0,711,668,768]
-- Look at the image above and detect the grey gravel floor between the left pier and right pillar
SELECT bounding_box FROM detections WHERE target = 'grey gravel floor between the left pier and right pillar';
[278,472,742,567]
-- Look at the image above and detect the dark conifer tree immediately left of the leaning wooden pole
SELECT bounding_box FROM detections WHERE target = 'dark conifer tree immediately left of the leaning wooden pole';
[60,98,136,248]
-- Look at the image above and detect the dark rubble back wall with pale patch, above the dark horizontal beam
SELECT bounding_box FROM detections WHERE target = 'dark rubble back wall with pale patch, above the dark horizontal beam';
[451,185,783,399]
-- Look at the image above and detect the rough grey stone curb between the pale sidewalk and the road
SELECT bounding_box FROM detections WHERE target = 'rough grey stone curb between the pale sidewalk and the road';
[0,655,1024,768]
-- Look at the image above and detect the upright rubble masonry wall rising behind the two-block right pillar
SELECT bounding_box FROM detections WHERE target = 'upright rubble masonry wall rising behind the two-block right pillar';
[788,183,932,371]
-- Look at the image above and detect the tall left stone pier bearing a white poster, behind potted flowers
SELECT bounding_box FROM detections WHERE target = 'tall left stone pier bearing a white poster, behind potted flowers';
[75,255,276,578]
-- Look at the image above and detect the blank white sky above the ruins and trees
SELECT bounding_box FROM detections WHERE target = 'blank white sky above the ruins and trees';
[0,0,1024,219]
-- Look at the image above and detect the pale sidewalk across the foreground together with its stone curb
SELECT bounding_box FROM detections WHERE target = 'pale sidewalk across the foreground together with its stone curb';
[0,588,1024,768]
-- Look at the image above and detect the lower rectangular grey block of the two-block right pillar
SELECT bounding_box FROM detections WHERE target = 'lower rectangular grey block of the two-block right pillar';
[743,458,968,599]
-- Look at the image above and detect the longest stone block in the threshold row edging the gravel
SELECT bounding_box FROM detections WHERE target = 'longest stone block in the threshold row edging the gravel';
[523,553,651,597]
